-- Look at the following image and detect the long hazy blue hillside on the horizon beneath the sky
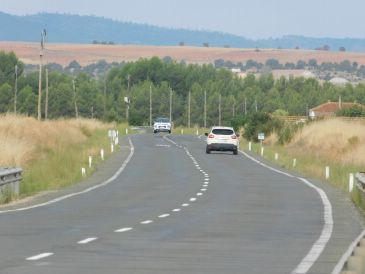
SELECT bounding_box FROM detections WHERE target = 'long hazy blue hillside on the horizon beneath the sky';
[0,12,365,51]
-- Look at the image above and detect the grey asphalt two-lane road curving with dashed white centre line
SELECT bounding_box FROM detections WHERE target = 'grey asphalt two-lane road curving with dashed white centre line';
[0,134,363,274]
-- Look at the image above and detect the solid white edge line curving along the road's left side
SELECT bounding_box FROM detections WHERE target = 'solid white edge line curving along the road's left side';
[0,137,134,214]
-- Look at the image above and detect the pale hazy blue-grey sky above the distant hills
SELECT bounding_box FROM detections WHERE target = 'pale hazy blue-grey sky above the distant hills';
[0,0,365,39]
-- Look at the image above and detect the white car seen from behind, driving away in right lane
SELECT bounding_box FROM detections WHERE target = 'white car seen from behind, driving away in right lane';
[205,127,239,155]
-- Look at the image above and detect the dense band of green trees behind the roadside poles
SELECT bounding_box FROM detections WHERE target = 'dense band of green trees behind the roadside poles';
[0,52,365,126]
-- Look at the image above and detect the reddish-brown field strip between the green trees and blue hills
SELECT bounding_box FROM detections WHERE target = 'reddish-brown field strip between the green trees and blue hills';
[0,42,365,66]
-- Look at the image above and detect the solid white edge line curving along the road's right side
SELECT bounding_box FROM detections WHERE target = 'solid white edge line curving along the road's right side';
[239,150,334,274]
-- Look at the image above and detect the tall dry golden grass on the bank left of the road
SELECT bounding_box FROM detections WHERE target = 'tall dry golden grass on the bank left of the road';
[0,114,108,167]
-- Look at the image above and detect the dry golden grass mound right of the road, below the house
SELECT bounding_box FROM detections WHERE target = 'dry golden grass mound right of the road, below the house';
[287,119,365,166]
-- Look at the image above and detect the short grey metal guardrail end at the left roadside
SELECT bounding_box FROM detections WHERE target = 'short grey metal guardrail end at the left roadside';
[0,167,23,197]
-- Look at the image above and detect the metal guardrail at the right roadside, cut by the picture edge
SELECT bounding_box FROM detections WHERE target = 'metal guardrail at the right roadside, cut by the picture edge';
[333,172,365,274]
